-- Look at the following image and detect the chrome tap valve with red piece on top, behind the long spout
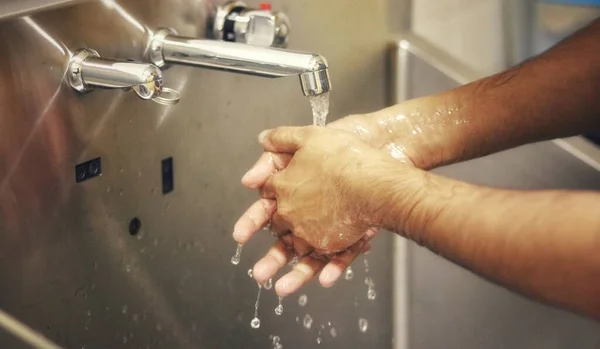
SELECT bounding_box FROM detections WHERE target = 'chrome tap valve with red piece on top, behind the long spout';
[213,1,290,47]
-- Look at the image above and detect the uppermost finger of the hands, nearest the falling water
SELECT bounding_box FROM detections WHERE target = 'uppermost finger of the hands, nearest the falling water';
[258,126,313,154]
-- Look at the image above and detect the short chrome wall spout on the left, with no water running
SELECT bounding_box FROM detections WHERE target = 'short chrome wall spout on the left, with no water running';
[68,49,179,105]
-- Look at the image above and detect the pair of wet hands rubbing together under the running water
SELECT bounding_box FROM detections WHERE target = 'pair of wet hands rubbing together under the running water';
[233,106,424,297]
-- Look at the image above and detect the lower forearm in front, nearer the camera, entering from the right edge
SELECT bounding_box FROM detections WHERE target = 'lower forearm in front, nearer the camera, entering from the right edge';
[382,166,600,319]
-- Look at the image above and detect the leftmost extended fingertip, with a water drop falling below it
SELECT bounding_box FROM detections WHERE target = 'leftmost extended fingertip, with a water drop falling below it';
[233,199,277,244]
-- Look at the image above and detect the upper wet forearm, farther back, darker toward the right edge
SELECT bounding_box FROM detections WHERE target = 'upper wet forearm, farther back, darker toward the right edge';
[369,20,600,169]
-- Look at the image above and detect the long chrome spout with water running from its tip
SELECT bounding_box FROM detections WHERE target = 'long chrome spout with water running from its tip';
[148,29,331,96]
